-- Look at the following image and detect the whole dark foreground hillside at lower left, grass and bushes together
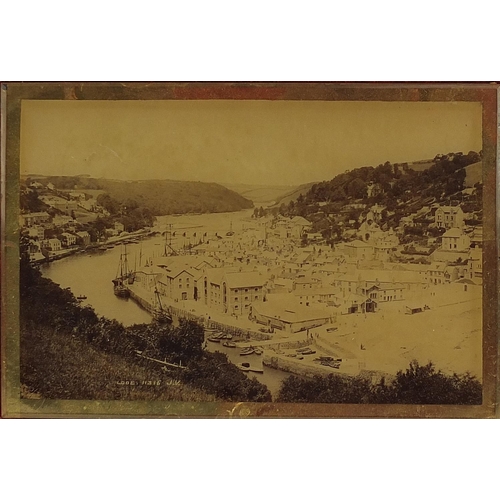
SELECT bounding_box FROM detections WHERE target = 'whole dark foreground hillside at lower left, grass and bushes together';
[20,238,271,402]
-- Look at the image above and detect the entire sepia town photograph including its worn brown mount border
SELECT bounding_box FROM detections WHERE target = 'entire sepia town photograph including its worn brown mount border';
[2,83,498,417]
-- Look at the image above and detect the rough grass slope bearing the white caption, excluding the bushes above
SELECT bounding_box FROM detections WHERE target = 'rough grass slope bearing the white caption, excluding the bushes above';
[21,327,215,402]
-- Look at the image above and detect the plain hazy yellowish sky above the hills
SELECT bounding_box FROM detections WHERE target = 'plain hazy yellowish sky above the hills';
[21,100,482,186]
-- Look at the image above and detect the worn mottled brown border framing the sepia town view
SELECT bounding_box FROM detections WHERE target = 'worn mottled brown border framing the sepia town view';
[0,82,498,418]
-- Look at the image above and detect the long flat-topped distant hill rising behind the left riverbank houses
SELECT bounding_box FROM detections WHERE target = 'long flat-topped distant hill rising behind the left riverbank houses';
[29,177,253,216]
